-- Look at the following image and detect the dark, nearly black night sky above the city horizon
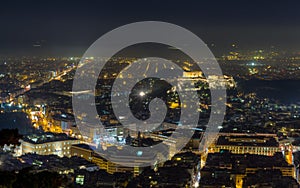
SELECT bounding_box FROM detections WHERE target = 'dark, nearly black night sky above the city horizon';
[0,0,300,56]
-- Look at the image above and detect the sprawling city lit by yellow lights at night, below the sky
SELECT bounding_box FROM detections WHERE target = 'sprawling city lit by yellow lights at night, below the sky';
[0,47,300,187]
